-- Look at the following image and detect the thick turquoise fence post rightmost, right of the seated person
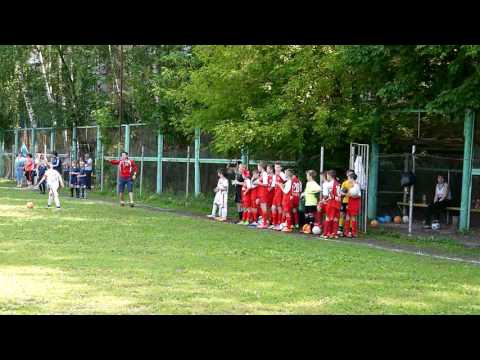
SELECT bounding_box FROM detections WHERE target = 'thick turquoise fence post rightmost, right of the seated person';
[459,110,475,231]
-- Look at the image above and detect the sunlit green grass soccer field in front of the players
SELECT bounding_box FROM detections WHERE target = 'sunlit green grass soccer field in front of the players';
[0,189,480,314]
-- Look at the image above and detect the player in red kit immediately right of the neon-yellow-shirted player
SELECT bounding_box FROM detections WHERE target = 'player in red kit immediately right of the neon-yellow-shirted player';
[323,170,342,239]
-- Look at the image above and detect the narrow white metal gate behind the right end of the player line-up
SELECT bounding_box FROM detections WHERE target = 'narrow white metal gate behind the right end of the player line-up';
[350,143,369,232]
